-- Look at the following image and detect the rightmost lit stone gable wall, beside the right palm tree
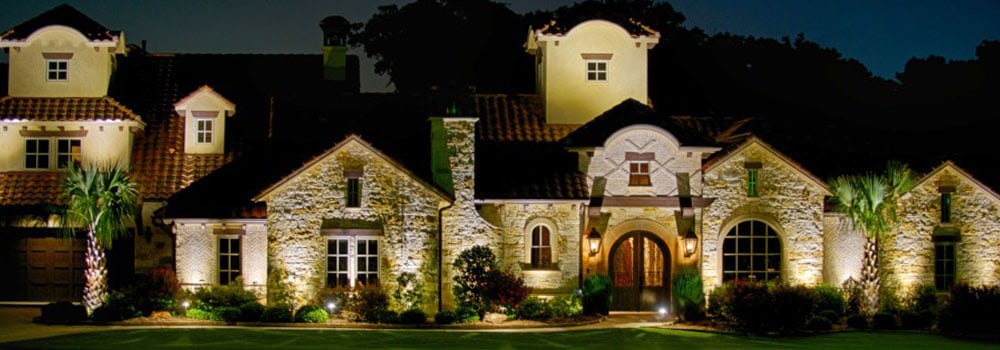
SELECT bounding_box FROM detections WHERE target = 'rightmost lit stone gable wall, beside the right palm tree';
[882,163,1000,296]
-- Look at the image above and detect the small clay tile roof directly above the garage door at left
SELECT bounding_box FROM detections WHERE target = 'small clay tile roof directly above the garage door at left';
[0,171,63,206]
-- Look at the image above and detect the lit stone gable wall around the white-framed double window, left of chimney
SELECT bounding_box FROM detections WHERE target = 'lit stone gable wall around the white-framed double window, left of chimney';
[265,139,443,310]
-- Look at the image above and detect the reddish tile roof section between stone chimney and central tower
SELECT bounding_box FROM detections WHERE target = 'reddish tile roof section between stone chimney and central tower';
[474,94,577,142]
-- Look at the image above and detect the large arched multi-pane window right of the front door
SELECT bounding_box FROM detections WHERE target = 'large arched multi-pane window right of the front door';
[722,220,782,281]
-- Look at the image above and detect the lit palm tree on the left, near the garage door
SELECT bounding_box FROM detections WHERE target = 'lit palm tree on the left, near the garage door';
[62,164,139,315]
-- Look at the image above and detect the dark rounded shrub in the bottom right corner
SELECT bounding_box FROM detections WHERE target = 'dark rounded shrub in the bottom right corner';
[938,284,1000,335]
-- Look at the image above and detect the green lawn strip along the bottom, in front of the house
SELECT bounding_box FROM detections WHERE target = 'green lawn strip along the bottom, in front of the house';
[0,328,1000,350]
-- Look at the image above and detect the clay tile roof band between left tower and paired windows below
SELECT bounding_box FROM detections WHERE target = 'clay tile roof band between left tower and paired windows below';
[0,96,142,121]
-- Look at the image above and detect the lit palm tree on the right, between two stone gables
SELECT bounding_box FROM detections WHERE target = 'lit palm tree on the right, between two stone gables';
[830,162,914,316]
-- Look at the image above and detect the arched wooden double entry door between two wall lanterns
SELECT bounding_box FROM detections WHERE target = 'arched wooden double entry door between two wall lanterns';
[608,231,671,311]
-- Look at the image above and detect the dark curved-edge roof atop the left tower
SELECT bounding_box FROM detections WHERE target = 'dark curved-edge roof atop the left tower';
[0,4,120,41]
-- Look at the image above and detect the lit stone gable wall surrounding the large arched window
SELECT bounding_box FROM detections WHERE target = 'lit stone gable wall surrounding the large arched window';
[702,141,825,290]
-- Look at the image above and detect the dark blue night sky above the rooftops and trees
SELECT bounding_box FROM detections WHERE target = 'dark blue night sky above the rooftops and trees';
[0,0,1000,91]
